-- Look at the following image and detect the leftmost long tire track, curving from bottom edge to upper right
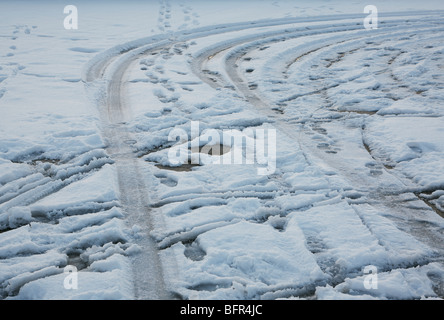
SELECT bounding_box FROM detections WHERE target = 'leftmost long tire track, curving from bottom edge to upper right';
[82,12,372,299]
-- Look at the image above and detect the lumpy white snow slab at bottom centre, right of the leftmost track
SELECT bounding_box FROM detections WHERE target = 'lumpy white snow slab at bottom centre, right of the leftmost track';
[163,221,325,299]
